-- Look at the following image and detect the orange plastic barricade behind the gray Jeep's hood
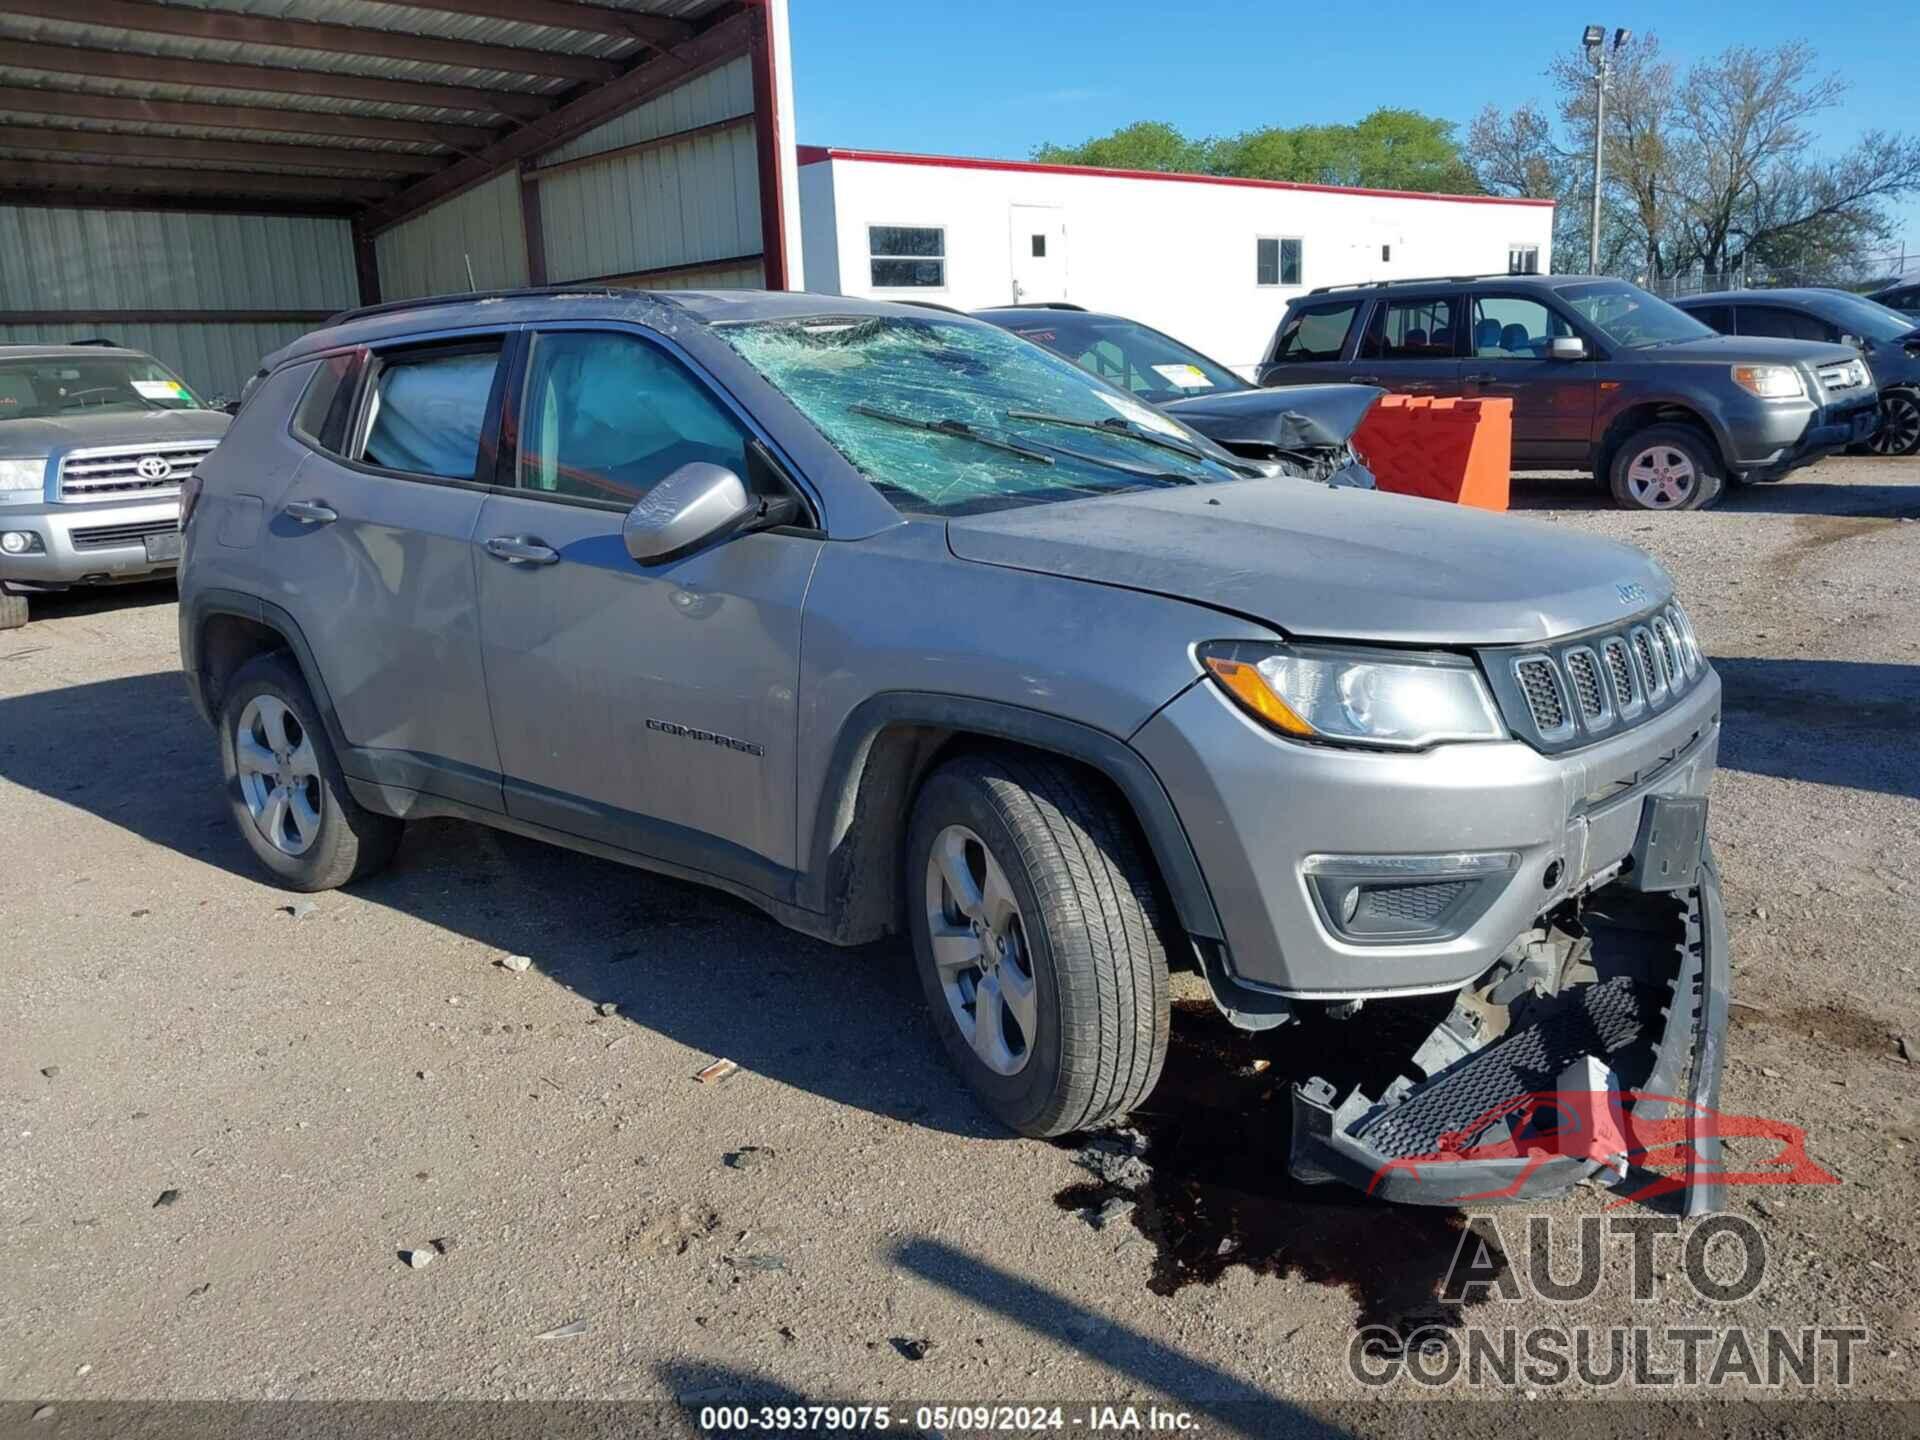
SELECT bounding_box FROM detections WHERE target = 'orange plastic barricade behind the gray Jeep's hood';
[1354,396,1513,511]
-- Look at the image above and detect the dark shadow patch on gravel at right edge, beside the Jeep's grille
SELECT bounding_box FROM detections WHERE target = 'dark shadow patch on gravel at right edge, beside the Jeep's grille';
[1713,655,1920,799]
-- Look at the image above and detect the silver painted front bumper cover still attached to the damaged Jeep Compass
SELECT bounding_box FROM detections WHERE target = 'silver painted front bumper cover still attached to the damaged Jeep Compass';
[1133,672,1720,1008]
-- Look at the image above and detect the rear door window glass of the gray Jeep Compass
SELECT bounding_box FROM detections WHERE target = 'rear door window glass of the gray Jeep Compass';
[357,336,501,480]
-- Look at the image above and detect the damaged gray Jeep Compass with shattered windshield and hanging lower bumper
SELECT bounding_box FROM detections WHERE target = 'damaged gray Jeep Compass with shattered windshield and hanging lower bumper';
[180,290,1728,1206]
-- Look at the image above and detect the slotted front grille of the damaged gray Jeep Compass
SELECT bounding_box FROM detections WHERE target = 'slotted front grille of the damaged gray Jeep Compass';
[1480,605,1707,751]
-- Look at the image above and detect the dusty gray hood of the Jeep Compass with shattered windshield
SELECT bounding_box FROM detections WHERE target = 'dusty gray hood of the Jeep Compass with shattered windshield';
[947,480,1672,645]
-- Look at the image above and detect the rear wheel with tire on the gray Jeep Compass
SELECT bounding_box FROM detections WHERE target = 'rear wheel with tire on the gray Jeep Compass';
[221,655,403,893]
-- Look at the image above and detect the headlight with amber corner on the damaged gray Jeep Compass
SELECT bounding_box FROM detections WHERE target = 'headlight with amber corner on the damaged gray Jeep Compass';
[1200,641,1507,749]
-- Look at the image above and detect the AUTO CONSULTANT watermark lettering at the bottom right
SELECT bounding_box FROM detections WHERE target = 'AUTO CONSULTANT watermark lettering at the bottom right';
[1348,1215,1870,1394]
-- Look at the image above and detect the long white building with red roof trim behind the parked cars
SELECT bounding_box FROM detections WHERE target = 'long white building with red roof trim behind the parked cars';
[799,146,1553,371]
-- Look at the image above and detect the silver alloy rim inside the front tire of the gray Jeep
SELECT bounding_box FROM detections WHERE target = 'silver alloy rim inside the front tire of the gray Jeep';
[927,826,1039,1075]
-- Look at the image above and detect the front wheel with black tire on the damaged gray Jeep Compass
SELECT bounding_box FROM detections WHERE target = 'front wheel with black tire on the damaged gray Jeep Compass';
[906,753,1169,1137]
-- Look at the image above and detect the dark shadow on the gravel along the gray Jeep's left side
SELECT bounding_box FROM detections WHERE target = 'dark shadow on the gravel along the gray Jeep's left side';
[0,672,1002,1135]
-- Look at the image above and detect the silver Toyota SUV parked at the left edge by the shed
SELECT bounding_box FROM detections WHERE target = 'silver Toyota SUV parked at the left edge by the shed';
[0,344,228,630]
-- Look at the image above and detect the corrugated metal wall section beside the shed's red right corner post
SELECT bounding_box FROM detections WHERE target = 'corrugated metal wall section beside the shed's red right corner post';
[533,56,760,286]
